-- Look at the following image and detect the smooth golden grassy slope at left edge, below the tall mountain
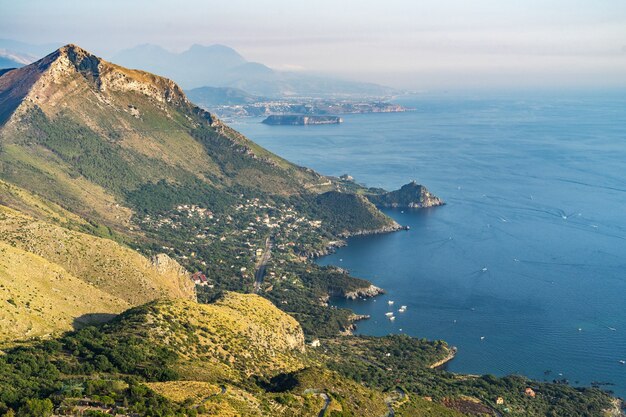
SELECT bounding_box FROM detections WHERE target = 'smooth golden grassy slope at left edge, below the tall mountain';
[0,203,194,343]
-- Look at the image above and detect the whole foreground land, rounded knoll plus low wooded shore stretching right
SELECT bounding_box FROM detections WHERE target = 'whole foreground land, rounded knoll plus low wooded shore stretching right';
[0,286,610,417]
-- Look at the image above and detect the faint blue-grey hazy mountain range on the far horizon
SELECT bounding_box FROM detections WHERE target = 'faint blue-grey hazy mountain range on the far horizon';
[111,45,395,97]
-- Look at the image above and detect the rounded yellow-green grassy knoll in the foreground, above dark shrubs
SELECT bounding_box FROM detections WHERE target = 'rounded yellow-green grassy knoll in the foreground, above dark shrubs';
[124,293,304,381]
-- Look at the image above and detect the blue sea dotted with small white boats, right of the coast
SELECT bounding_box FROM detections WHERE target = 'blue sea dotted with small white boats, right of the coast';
[233,91,626,397]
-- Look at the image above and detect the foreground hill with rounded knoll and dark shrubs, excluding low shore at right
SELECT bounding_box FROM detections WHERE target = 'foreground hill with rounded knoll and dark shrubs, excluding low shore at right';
[0,293,387,417]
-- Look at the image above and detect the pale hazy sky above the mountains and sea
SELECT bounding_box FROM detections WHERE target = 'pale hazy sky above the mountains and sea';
[0,0,626,89]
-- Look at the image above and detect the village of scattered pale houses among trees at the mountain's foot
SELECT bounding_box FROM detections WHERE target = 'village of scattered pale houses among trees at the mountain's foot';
[137,196,330,290]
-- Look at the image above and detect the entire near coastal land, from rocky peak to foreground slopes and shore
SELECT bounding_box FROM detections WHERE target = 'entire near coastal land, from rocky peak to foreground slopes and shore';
[0,45,619,417]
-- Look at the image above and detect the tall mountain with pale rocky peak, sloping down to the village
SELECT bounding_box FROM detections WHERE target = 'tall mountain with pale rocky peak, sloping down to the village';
[0,45,397,329]
